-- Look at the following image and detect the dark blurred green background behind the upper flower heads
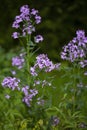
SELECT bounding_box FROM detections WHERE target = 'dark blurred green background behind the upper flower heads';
[0,0,87,61]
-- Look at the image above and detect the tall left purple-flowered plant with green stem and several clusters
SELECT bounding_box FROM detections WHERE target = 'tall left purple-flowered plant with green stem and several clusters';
[1,5,60,127]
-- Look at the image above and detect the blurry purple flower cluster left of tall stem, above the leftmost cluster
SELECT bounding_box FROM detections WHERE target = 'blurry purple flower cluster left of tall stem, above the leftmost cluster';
[12,54,25,69]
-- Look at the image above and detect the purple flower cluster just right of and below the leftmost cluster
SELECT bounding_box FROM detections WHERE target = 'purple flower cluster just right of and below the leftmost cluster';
[22,86,38,107]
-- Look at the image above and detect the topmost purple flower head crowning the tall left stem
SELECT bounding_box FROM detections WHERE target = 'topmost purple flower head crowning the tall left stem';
[12,5,43,43]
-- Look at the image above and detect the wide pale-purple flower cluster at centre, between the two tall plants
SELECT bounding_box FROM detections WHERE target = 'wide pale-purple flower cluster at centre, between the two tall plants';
[30,54,60,76]
